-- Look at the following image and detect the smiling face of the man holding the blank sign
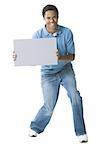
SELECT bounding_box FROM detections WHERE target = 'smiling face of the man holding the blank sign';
[44,10,58,31]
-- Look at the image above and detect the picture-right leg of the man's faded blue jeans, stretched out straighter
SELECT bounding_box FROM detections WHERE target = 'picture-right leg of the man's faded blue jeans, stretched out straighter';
[62,67,86,135]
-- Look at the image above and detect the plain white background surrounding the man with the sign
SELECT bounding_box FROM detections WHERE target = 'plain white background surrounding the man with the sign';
[0,0,109,150]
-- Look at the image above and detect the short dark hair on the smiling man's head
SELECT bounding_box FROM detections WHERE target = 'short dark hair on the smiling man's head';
[42,5,59,18]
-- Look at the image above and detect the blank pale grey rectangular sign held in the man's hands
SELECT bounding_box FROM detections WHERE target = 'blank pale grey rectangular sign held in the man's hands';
[13,37,57,66]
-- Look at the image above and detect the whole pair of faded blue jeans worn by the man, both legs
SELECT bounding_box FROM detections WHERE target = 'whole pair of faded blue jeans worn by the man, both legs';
[30,63,86,135]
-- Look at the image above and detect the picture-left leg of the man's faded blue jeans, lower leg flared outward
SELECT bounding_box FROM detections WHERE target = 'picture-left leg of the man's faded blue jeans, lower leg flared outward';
[30,75,60,133]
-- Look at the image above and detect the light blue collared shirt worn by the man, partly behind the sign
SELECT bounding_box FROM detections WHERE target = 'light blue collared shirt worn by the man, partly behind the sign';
[33,25,75,74]
